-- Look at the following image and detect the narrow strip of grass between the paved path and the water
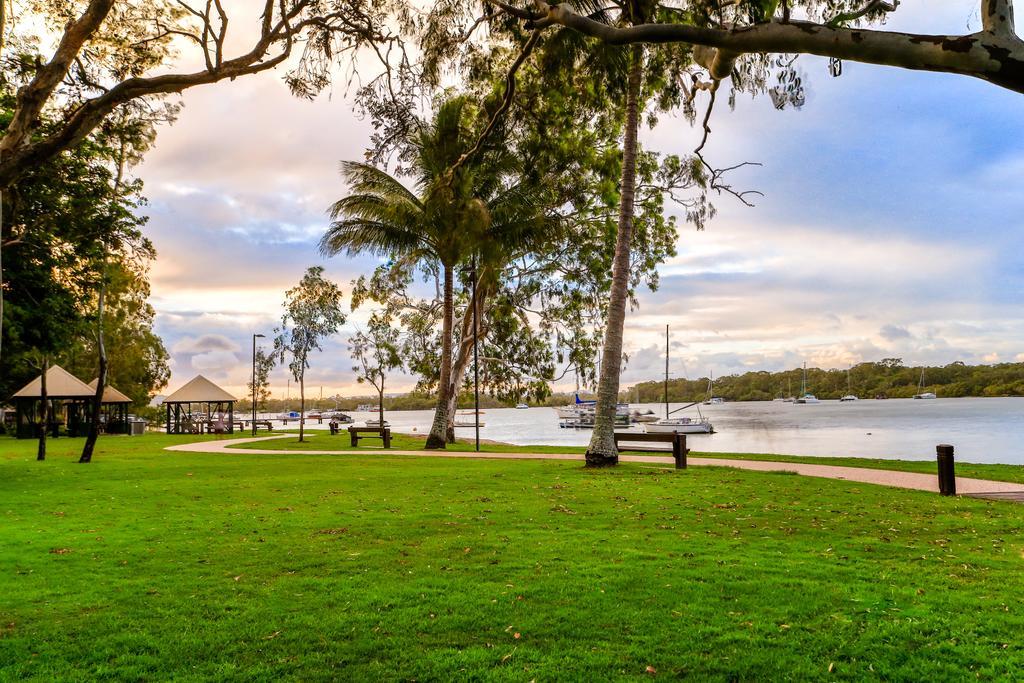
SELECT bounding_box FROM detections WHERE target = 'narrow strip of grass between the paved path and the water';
[235,430,1024,483]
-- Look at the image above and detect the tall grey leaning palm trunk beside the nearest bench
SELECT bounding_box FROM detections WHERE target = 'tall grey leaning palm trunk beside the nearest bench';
[586,45,643,467]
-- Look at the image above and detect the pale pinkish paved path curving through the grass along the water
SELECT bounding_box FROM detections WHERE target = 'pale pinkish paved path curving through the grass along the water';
[166,434,1024,500]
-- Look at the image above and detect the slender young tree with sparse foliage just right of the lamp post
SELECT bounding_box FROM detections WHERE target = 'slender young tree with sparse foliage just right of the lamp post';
[273,266,345,441]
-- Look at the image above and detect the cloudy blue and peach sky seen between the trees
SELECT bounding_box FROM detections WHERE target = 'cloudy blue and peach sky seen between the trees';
[135,0,1024,396]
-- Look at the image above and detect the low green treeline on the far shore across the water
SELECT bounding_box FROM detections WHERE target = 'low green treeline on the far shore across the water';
[621,358,1024,402]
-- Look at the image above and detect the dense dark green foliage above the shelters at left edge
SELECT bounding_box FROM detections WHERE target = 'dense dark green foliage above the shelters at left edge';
[0,88,170,404]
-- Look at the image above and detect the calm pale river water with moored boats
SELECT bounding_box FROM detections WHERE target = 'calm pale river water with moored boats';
[268,398,1024,465]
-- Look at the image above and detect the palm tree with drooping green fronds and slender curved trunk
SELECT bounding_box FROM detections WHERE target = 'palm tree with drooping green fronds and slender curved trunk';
[321,97,494,449]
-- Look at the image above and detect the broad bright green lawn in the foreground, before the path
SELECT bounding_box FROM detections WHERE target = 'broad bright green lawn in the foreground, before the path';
[6,435,1024,681]
